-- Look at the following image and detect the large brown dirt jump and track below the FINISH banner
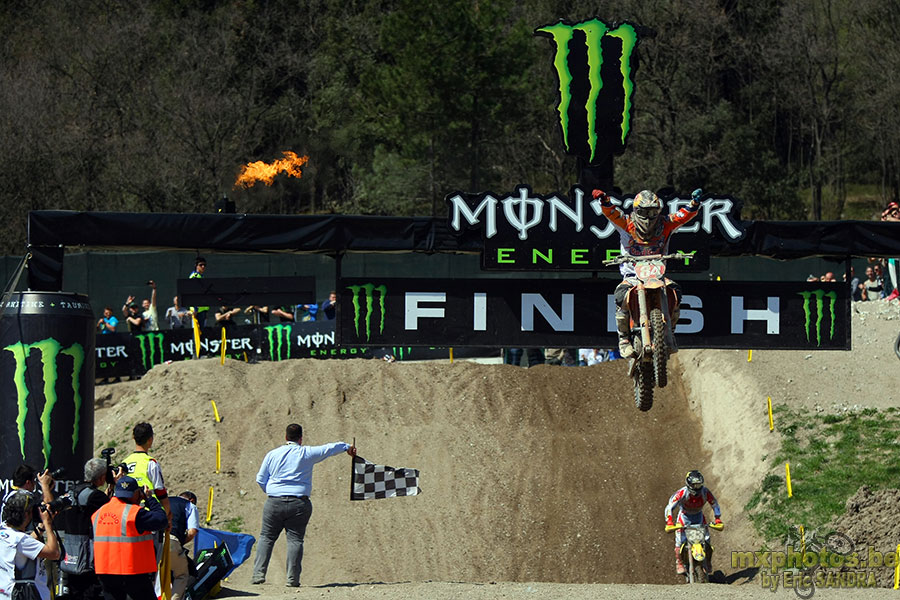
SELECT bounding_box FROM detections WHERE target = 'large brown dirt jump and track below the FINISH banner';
[95,298,897,600]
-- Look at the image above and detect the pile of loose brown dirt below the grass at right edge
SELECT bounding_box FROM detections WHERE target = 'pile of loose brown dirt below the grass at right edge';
[830,486,900,587]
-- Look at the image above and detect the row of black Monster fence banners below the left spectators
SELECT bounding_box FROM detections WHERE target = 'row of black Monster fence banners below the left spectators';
[95,321,497,379]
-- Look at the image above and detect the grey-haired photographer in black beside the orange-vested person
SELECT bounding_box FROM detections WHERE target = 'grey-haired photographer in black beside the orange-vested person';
[56,458,109,600]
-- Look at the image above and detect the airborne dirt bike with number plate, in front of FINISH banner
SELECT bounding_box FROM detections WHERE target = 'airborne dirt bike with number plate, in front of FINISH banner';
[603,254,692,411]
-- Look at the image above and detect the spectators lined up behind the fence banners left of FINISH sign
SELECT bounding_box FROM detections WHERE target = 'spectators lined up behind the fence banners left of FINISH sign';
[97,257,337,334]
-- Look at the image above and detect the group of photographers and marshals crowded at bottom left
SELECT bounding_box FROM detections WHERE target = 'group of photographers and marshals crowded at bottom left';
[0,423,199,600]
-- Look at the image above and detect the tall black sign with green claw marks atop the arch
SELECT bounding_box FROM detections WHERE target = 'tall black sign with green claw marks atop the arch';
[534,19,638,163]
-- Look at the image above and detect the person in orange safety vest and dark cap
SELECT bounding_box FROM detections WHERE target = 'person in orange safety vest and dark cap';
[91,475,169,600]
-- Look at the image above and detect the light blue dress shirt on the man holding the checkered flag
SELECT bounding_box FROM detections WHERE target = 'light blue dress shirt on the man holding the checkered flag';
[256,442,350,496]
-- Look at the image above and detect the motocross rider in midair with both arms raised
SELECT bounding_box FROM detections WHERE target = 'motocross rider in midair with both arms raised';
[593,189,703,358]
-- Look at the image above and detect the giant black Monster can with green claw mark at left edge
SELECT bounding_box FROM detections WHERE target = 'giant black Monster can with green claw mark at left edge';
[0,292,94,493]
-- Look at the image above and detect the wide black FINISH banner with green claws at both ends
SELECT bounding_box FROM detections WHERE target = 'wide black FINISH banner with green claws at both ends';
[338,278,850,350]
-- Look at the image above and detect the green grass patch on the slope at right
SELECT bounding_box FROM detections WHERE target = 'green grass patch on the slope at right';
[744,405,900,541]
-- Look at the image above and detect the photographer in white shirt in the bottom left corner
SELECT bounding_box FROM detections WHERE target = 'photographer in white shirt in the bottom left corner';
[0,491,59,600]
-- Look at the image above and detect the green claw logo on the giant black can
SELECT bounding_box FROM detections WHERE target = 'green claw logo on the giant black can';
[4,338,84,468]
